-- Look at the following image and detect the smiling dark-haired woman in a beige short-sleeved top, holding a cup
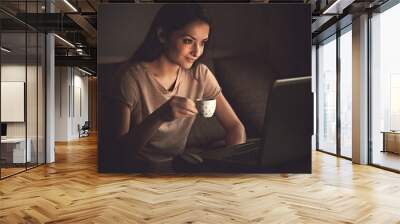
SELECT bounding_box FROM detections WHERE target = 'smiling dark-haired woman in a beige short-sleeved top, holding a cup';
[114,4,246,172]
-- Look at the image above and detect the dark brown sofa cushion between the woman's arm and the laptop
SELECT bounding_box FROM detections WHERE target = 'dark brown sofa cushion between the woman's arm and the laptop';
[214,57,275,137]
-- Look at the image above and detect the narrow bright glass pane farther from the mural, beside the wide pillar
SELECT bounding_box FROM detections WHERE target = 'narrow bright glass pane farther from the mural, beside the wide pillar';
[340,30,353,158]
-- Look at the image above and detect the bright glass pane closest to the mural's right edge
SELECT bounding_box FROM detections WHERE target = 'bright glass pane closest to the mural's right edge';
[318,38,336,154]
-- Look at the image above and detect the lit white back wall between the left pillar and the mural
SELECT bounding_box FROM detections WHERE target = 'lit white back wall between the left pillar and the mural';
[55,67,89,141]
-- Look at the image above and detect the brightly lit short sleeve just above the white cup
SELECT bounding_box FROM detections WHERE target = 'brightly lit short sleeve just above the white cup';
[198,64,221,99]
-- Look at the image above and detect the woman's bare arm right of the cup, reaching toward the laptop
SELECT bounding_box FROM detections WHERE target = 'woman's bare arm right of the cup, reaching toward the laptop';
[215,93,246,145]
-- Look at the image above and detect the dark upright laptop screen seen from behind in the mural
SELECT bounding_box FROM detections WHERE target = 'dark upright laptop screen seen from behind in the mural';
[260,76,313,173]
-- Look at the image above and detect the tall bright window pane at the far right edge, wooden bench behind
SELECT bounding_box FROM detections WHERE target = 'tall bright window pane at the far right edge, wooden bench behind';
[371,4,400,170]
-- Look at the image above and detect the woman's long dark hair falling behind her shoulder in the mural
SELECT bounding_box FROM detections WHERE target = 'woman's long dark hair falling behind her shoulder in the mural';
[130,4,211,62]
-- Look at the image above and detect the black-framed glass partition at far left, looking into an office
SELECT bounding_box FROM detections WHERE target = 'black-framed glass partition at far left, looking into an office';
[0,1,46,178]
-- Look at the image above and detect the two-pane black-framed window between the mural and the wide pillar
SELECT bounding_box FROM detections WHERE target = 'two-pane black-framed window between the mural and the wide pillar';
[317,24,353,158]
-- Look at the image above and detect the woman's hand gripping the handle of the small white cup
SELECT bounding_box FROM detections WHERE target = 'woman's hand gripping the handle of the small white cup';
[159,96,198,121]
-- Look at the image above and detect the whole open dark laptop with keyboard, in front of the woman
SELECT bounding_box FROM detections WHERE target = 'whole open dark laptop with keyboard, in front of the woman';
[199,76,313,173]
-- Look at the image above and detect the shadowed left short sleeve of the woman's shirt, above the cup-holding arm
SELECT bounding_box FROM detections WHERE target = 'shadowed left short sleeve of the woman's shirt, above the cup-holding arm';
[113,66,138,111]
